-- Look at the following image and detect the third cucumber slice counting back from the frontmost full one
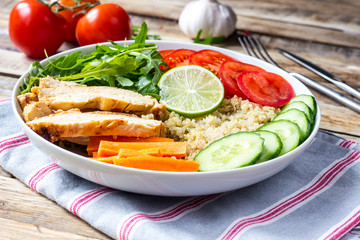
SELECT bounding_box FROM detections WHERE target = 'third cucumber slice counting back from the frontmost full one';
[259,120,301,156]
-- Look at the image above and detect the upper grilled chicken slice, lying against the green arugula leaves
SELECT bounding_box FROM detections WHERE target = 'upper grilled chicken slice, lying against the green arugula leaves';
[31,77,166,119]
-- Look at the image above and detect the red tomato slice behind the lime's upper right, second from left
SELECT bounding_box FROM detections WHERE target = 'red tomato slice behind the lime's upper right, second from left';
[190,49,236,76]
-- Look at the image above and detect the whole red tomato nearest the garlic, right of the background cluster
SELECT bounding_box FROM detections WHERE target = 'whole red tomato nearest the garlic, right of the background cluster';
[75,3,132,46]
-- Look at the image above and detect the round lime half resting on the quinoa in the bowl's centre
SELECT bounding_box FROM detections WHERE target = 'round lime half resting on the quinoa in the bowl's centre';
[159,65,224,118]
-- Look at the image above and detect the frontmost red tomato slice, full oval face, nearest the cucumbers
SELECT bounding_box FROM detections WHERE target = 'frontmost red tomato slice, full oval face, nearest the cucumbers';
[236,72,295,107]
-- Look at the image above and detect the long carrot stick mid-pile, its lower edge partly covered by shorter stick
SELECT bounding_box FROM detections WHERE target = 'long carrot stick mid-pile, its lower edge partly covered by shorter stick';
[98,141,186,158]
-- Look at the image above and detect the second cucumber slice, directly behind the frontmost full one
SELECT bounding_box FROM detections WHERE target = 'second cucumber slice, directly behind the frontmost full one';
[255,130,282,164]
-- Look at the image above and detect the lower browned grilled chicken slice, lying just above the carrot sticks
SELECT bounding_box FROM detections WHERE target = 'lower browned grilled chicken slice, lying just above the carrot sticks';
[26,109,165,142]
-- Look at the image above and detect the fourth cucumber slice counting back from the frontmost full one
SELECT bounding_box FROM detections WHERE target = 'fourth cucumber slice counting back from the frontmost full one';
[273,108,310,143]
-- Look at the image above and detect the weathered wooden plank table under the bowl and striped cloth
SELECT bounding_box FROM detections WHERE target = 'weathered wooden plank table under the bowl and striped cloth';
[0,0,360,239]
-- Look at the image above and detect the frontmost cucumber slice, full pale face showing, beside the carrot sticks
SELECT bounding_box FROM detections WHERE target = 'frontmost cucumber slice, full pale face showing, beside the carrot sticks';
[194,132,264,171]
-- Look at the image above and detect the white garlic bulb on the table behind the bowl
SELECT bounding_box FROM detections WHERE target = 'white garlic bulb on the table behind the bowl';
[179,0,236,39]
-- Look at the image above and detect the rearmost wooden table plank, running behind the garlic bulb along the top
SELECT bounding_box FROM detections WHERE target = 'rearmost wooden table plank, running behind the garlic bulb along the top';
[103,0,360,47]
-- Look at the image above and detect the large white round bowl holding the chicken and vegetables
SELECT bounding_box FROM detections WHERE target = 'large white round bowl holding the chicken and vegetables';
[12,41,320,196]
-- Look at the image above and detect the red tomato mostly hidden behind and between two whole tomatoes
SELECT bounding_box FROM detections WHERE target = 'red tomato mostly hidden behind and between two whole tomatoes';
[52,0,100,42]
